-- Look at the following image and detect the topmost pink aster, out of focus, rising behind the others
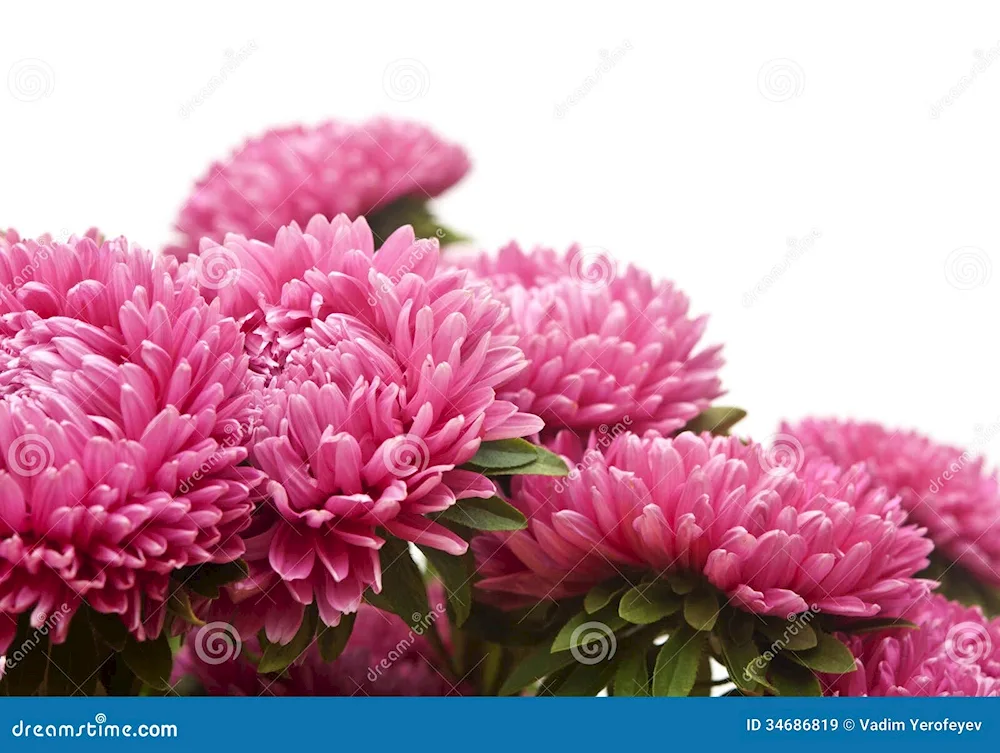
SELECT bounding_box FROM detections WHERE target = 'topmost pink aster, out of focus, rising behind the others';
[168,118,469,259]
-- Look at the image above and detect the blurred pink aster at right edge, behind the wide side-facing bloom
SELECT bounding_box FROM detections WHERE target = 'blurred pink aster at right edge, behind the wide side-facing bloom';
[781,419,1000,586]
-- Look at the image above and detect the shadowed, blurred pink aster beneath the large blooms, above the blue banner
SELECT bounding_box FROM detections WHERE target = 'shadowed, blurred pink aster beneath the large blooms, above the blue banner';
[173,600,474,697]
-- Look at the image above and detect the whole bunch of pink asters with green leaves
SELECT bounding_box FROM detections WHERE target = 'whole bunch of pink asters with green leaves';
[0,119,1000,696]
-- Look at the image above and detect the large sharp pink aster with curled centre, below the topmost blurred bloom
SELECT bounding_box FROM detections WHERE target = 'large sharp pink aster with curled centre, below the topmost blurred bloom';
[199,215,542,642]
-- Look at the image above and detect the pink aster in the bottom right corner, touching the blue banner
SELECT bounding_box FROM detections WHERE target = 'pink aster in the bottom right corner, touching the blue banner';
[821,596,1000,696]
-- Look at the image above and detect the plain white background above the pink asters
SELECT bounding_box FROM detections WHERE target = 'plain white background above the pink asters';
[0,0,1000,460]
